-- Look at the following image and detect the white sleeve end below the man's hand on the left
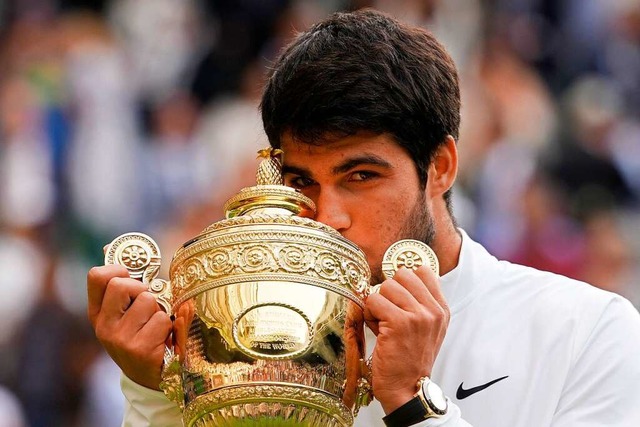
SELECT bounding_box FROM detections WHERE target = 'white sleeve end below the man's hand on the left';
[120,374,182,427]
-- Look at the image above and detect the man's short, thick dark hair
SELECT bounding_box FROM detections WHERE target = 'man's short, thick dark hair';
[261,10,460,211]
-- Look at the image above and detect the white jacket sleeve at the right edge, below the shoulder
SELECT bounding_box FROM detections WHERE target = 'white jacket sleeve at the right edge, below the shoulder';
[551,297,640,427]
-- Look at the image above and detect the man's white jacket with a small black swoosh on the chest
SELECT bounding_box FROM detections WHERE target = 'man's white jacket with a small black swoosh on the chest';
[123,232,640,427]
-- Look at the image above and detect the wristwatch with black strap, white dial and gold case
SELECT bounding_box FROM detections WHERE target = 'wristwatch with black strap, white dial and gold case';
[382,377,449,427]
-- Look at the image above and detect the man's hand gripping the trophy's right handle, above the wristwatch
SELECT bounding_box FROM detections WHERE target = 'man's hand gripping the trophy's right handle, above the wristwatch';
[365,266,449,414]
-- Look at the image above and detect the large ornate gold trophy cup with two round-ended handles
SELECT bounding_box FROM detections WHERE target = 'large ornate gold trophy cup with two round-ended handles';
[105,149,438,427]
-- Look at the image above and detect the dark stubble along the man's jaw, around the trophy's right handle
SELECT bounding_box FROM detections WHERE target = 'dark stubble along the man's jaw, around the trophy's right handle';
[370,192,436,285]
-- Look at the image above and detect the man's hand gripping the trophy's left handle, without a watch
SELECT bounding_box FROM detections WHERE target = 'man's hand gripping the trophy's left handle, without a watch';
[87,265,172,390]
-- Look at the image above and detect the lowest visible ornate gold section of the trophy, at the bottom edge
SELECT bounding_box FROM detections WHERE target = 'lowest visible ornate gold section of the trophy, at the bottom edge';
[184,382,353,427]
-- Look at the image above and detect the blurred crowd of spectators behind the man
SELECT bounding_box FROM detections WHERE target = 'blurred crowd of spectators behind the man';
[0,0,640,427]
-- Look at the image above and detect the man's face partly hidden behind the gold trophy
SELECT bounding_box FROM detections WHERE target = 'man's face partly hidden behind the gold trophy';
[281,133,435,283]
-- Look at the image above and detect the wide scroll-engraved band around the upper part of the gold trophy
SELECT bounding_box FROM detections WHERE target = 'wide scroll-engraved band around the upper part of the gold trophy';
[170,232,370,305]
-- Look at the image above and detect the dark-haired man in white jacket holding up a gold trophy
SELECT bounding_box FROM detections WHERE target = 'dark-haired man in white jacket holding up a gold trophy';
[88,11,640,427]
